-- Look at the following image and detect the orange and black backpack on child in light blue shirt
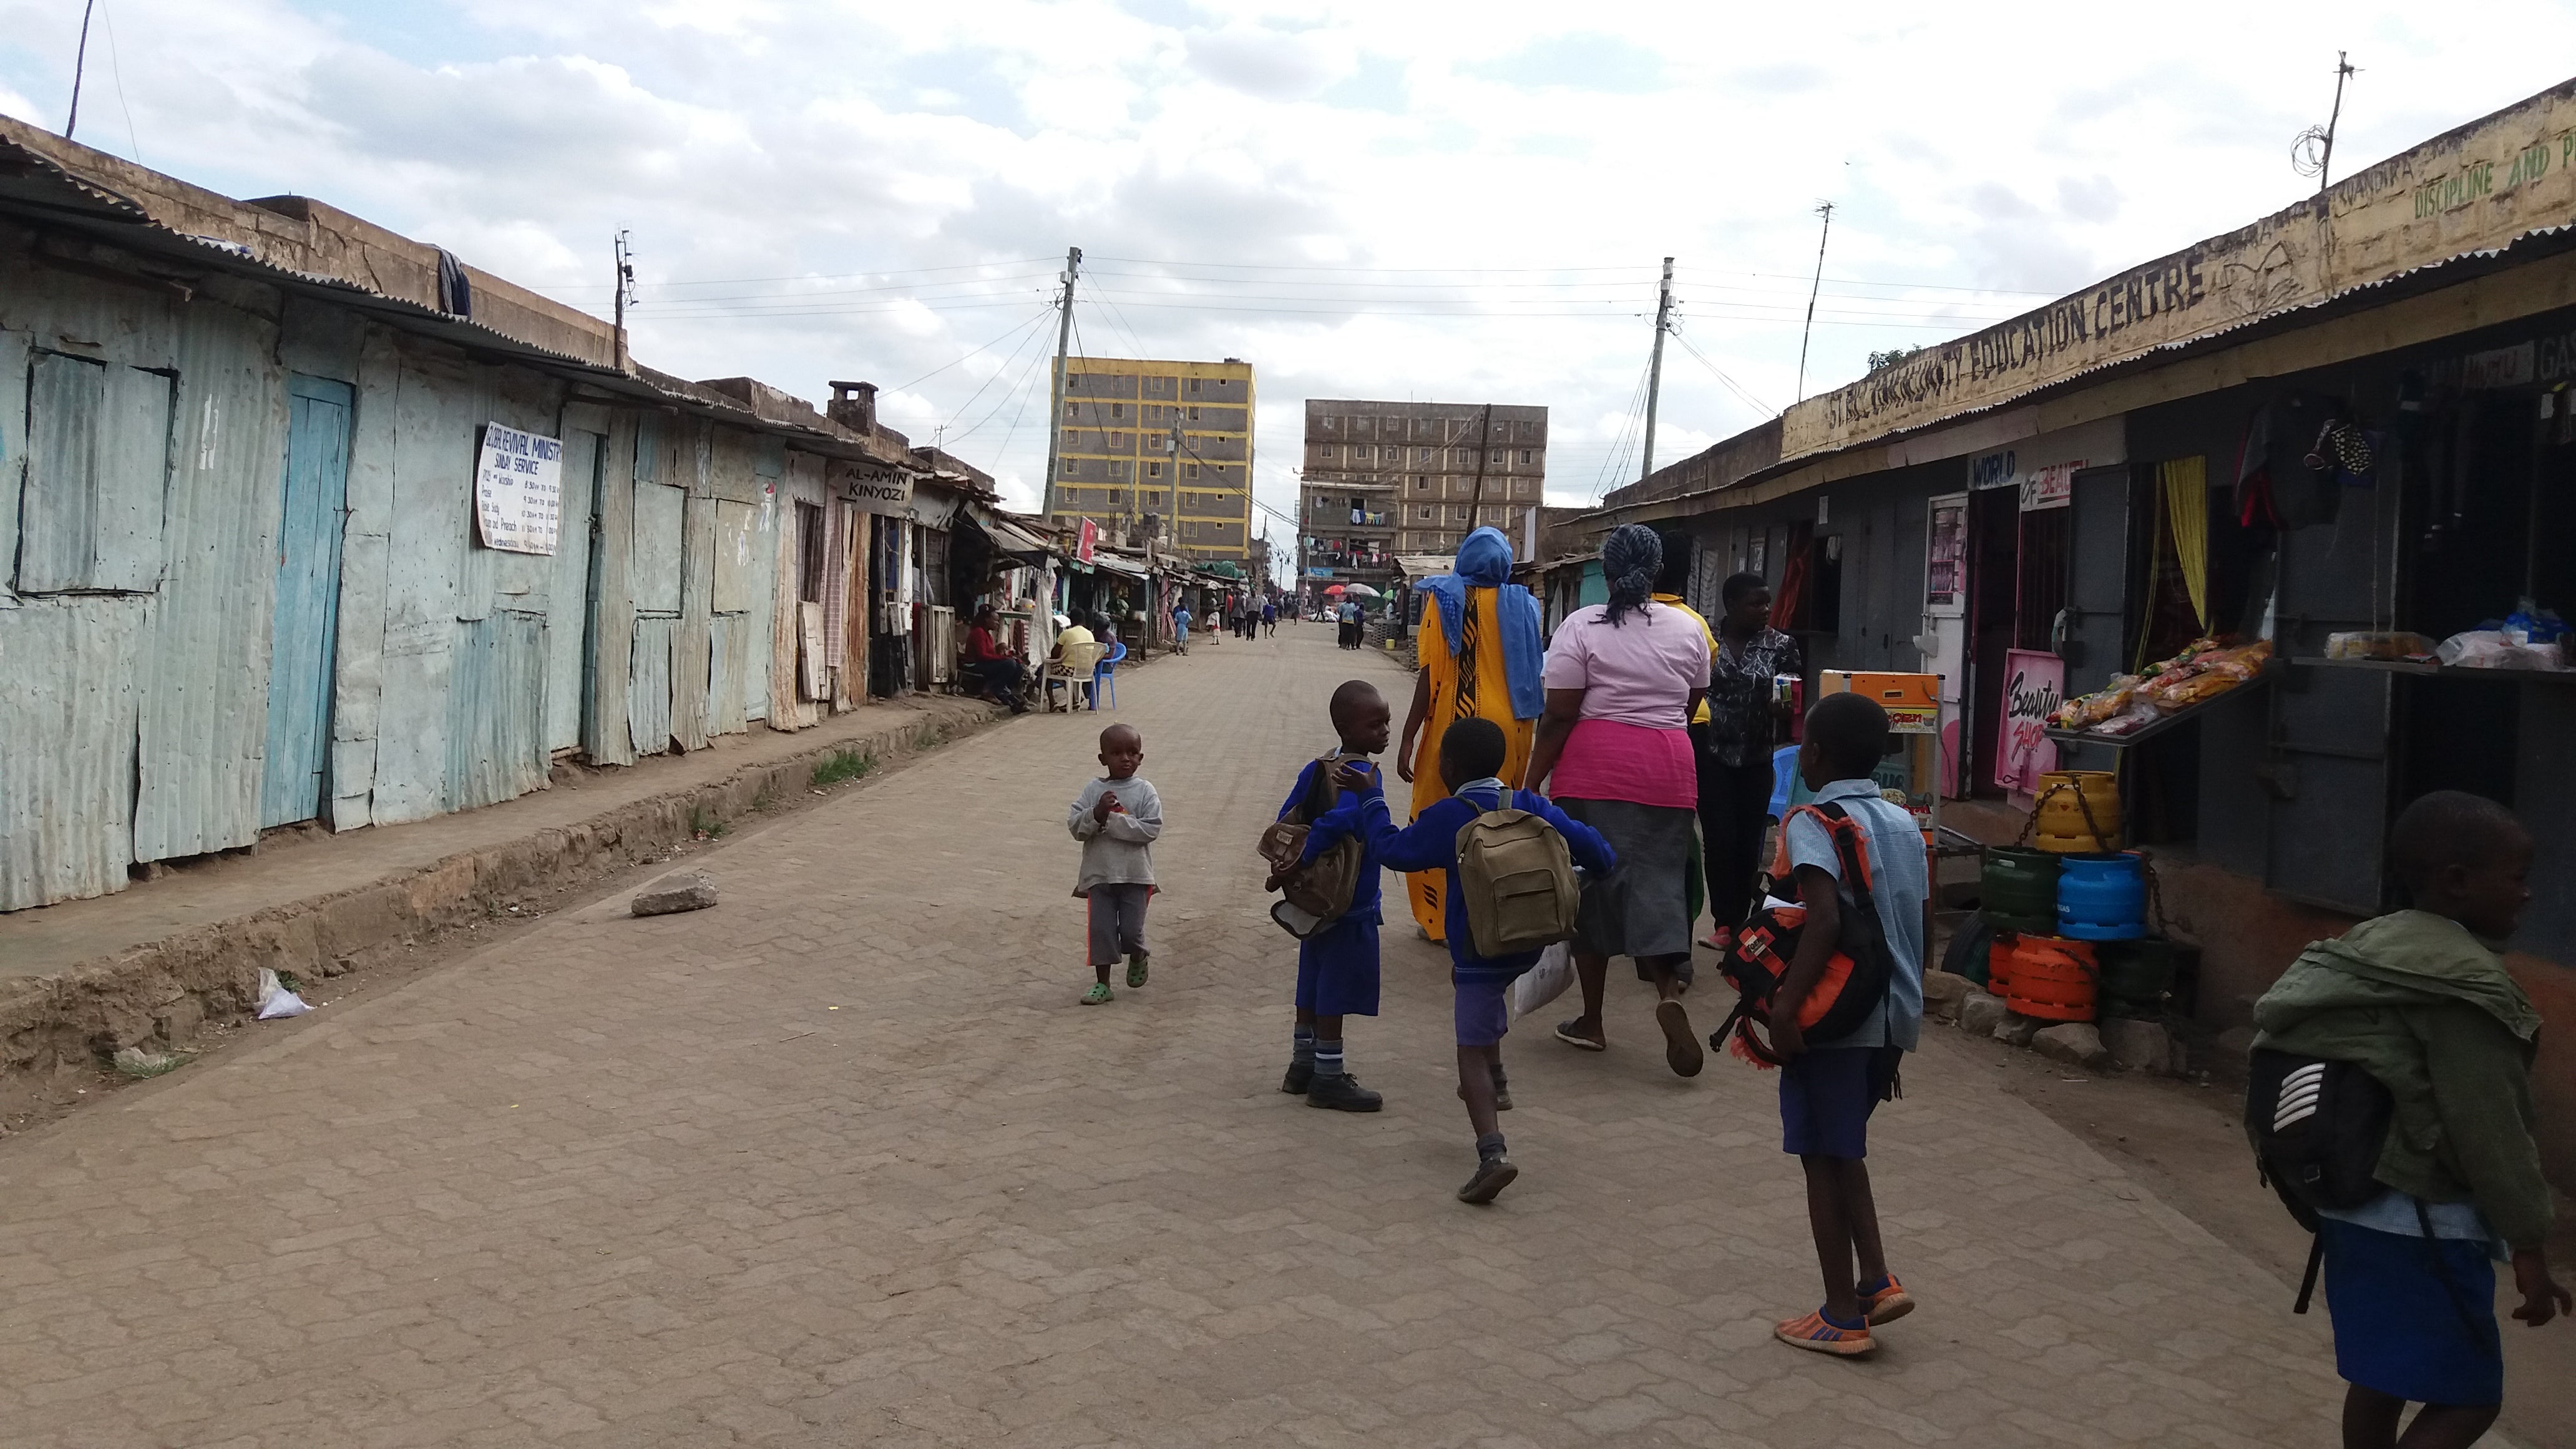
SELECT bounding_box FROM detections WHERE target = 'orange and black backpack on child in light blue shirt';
[1708,799,1896,1070]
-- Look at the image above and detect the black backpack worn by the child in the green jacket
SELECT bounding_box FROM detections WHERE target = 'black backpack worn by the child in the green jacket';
[2247,1046,2483,1344]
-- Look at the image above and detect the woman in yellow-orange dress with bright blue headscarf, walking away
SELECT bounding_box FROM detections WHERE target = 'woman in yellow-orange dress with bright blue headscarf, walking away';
[1396,529,1548,941]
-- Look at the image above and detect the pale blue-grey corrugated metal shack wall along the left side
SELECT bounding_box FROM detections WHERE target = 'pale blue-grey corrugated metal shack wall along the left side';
[0,250,858,910]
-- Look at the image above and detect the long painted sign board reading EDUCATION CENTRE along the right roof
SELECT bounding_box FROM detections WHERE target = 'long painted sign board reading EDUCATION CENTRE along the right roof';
[1780,80,2576,459]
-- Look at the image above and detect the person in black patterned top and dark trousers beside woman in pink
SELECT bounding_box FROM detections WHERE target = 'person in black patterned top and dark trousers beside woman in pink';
[1690,572,1803,952]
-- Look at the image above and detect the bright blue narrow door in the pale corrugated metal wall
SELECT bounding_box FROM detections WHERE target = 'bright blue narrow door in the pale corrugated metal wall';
[260,374,353,827]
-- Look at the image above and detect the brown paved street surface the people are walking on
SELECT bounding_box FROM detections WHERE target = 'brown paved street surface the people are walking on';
[0,624,2341,1449]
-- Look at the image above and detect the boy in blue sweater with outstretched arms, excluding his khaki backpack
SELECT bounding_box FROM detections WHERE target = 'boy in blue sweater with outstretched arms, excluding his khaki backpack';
[1306,717,1617,1204]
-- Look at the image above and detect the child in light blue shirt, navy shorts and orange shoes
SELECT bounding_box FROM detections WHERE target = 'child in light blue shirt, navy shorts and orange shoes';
[1770,693,1932,1356]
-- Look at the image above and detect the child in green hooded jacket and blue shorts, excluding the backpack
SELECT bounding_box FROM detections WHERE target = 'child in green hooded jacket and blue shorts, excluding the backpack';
[2254,789,2571,1449]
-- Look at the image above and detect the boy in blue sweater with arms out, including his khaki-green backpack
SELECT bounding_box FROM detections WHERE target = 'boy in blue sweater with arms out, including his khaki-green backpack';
[1306,717,1617,1204]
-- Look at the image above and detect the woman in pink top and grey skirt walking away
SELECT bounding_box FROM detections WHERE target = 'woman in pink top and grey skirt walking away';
[1528,524,1708,1078]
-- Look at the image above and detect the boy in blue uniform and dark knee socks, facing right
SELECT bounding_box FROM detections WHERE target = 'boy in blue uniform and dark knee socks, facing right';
[1277,678,1393,1111]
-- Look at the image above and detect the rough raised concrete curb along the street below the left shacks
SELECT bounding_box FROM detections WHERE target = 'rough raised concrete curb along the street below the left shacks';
[0,696,1002,1096]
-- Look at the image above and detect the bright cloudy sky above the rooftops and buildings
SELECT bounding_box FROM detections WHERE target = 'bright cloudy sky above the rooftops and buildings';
[0,0,2576,539]
